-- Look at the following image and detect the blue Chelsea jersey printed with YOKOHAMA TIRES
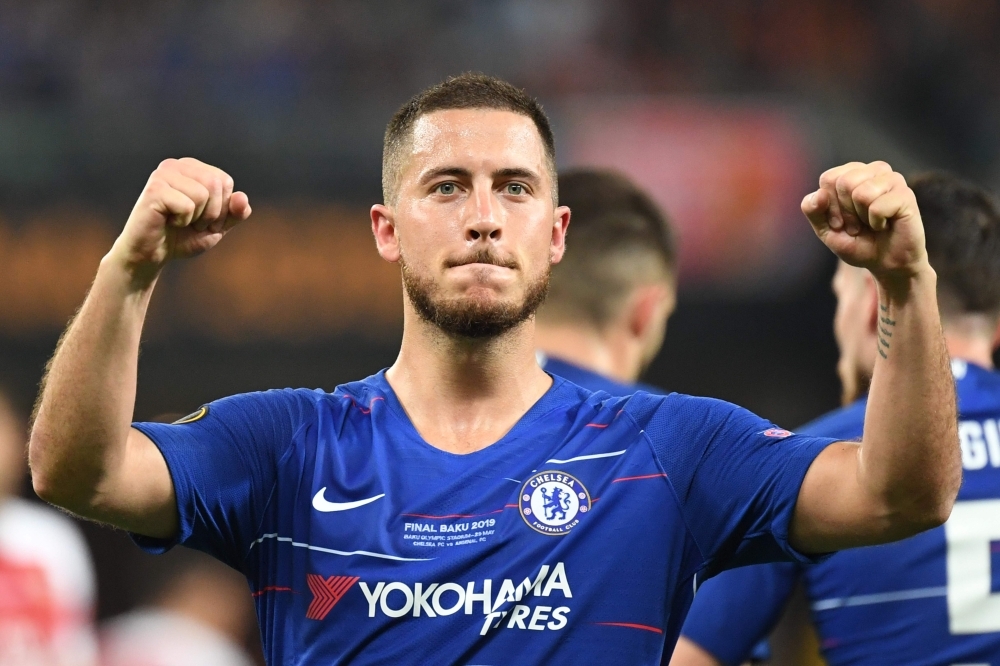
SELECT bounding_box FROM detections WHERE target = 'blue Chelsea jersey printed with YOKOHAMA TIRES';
[135,371,833,665]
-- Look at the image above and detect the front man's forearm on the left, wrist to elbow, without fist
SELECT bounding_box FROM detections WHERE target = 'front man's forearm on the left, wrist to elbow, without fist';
[29,254,155,508]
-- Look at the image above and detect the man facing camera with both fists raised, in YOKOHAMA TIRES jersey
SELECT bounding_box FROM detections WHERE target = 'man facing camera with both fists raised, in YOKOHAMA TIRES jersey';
[30,74,961,664]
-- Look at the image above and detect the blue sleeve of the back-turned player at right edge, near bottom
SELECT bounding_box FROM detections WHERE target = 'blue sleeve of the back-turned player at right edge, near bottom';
[681,562,801,666]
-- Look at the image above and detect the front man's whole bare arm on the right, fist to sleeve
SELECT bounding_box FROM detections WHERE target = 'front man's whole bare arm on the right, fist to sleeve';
[790,162,962,553]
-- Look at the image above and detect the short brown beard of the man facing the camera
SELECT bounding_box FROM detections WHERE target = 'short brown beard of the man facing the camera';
[400,253,549,339]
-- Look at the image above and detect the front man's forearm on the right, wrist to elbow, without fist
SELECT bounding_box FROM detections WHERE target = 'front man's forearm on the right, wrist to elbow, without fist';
[859,266,961,536]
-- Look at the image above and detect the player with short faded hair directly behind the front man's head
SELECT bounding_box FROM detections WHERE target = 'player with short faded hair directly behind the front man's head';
[535,168,677,395]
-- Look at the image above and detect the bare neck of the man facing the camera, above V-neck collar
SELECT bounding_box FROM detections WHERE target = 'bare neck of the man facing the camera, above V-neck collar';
[386,309,552,453]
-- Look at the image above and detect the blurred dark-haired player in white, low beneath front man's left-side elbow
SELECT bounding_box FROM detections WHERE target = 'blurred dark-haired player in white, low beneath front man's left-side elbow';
[101,553,256,666]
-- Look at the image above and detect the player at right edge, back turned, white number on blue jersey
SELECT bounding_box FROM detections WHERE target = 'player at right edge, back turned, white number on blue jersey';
[671,174,1000,666]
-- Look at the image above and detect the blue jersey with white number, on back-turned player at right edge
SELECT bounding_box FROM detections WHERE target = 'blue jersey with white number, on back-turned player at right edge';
[682,360,1000,666]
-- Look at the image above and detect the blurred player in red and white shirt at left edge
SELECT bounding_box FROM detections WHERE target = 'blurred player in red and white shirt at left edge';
[0,389,97,666]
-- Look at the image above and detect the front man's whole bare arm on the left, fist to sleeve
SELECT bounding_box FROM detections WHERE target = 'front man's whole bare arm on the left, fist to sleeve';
[28,158,250,538]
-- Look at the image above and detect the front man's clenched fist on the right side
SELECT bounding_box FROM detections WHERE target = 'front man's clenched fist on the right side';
[802,162,927,280]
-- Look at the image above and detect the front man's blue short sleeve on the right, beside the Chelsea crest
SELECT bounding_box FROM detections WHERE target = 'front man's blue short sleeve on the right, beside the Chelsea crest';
[628,394,836,578]
